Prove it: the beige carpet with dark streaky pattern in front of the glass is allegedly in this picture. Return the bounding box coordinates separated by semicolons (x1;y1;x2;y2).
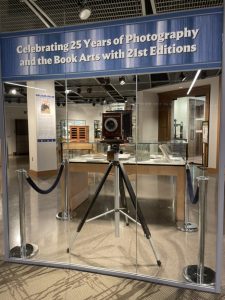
0;261;225;300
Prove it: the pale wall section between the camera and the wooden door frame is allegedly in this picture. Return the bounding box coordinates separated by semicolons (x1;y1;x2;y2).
137;91;159;143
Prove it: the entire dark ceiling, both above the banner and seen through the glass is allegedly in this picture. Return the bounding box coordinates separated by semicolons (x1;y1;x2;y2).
0;0;223;105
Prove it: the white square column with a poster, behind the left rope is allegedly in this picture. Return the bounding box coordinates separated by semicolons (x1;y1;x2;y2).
27;81;57;174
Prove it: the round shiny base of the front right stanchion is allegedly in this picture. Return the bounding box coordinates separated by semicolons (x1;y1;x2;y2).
183;265;215;285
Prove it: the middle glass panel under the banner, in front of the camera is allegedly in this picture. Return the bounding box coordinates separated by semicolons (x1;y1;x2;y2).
64;76;136;273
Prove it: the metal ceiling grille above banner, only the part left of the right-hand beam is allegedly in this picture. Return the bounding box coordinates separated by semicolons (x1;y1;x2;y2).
0;0;143;32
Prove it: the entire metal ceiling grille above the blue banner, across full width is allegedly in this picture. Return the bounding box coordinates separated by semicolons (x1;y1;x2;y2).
0;0;223;32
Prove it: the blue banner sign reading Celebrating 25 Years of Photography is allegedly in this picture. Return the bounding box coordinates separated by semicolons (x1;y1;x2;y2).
1;9;223;80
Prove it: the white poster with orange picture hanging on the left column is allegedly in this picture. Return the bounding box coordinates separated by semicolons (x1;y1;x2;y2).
35;94;56;142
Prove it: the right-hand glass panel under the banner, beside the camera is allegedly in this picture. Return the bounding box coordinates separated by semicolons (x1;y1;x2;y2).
137;70;219;284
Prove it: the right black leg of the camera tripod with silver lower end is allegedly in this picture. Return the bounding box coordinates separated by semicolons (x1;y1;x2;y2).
118;164;161;266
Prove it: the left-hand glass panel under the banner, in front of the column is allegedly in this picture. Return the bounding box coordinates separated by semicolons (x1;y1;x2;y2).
4;80;68;261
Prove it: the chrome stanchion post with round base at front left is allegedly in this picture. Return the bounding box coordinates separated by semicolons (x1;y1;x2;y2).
10;169;38;258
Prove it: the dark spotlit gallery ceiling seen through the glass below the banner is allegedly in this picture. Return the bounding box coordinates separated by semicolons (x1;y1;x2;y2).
4;70;220;106
